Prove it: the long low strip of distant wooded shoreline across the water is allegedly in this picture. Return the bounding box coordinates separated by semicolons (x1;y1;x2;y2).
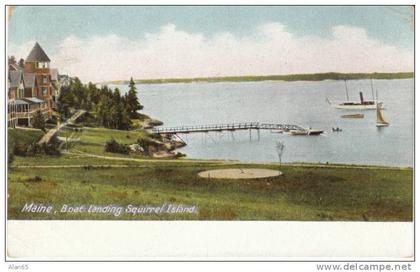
97;72;414;85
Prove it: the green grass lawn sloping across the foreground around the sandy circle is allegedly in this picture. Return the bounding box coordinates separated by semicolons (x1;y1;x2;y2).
8;126;413;221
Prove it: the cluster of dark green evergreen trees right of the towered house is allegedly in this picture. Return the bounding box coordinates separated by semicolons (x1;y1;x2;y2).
57;78;143;130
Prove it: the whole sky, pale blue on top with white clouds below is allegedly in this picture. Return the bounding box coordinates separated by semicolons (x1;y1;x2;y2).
8;6;414;82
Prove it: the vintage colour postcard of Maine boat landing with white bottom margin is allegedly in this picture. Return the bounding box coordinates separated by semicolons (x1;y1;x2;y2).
5;3;414;258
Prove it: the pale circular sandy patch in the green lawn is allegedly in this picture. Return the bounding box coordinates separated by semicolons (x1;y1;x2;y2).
198;168;282;179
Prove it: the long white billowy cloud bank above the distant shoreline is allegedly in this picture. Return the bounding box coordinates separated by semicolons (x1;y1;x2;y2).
7;22;414;82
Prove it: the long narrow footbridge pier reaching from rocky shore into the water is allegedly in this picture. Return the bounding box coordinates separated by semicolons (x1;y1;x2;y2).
152;122;304;134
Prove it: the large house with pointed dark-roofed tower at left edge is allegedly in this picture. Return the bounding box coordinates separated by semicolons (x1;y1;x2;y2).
8;43;59;127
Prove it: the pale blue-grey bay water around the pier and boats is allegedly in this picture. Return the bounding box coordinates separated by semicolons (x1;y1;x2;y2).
111;79;414;166
